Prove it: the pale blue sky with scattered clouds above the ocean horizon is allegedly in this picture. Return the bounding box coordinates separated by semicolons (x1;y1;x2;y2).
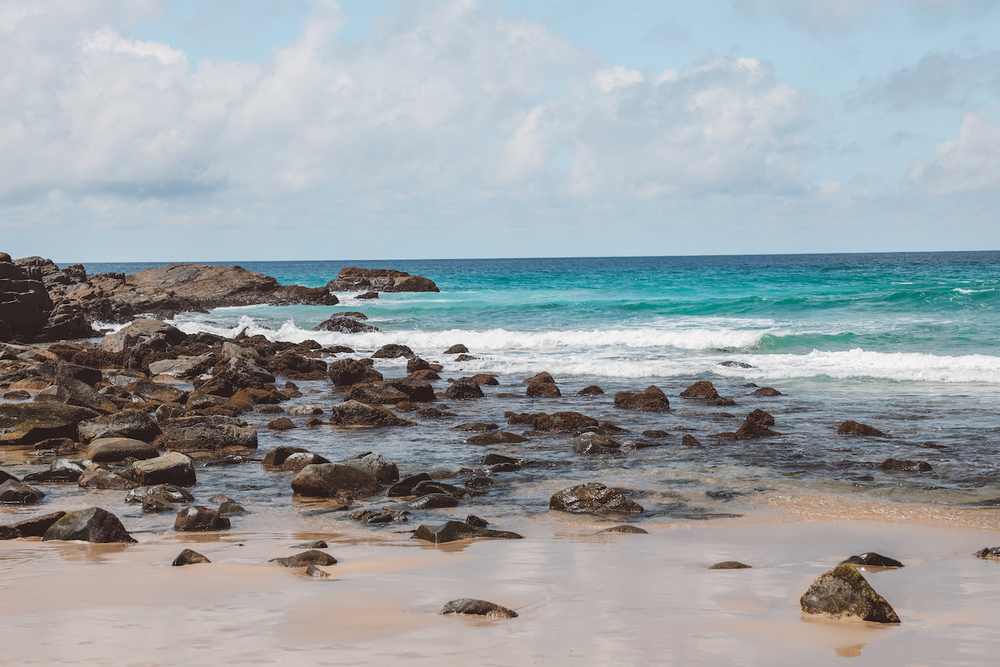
0;0;1000;262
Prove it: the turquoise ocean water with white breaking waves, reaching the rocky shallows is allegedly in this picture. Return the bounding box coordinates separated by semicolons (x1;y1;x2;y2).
70;252;1000;536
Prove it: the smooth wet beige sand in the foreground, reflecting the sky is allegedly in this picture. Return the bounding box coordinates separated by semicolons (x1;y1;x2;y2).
0;512;1000;665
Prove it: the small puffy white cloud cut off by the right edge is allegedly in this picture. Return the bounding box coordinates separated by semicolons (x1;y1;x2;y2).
907;110;1000;195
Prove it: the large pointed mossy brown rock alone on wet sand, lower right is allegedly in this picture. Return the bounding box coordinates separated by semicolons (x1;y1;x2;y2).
799;563;899;623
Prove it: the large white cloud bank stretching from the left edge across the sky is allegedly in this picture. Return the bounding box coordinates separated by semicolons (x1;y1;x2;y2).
0;0;810;210
